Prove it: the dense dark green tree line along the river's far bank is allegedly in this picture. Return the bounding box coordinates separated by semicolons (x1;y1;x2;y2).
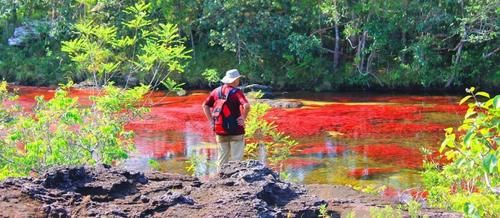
0;0;500;90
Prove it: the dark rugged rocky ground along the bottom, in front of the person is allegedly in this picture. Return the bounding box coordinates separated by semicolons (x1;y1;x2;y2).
0;161;457;217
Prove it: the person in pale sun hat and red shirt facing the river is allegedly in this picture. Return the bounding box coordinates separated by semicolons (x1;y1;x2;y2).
202;69;250;170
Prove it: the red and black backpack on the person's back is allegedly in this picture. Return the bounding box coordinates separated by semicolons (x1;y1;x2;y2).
212;86;238;134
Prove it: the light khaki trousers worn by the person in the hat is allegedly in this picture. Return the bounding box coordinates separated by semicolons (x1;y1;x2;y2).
215;135;245;171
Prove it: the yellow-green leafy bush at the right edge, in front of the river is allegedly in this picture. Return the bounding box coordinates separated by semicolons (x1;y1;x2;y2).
423;87;500;216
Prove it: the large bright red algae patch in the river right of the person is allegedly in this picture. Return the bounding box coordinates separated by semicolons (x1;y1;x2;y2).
266;104;456;137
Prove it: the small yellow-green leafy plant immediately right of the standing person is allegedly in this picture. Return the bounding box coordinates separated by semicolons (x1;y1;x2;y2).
245;100;298;175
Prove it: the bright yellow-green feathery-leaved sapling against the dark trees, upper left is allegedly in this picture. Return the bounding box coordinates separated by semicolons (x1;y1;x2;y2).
61;1;190;87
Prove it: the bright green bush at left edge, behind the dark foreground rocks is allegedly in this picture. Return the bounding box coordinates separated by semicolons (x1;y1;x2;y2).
0;82;149;179
